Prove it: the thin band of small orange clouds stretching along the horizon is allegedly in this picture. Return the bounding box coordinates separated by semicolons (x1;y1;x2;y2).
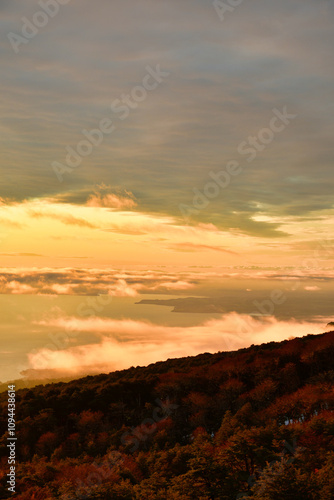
0;266;334;296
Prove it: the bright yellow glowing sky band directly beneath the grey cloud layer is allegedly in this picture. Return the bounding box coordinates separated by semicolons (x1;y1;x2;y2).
0;197;334;267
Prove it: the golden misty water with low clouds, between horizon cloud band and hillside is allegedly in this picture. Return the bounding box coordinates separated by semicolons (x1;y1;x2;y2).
0;279;333;382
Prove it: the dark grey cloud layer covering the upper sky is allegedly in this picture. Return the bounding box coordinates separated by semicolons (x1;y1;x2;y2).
0;0;334;234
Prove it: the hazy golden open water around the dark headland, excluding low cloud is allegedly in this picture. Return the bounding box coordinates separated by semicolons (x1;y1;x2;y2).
0;279;328;382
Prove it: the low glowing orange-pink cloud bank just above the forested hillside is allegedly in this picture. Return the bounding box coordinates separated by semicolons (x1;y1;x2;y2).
25;313;323;377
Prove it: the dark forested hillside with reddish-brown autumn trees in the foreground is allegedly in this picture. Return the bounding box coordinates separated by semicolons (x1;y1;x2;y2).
0;332;334;500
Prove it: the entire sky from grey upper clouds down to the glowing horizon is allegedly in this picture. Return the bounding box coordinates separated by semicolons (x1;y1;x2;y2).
0;0;334;384
